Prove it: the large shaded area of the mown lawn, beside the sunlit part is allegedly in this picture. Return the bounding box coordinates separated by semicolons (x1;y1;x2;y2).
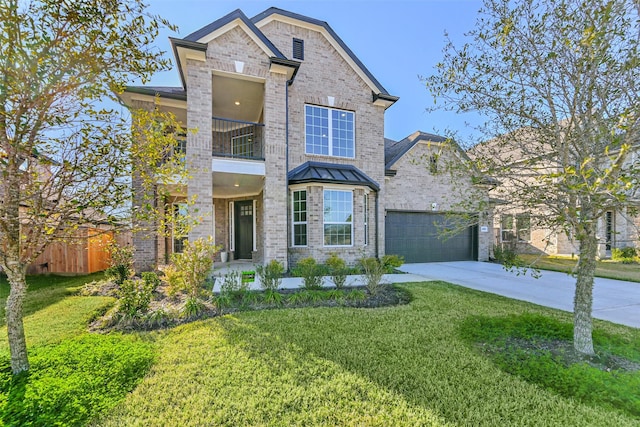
211;283;637;425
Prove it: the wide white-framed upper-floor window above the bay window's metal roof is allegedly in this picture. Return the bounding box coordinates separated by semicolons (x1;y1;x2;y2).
305;105;355;158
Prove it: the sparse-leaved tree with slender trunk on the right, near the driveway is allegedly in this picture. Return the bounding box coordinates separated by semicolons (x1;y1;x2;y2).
424;0;640;354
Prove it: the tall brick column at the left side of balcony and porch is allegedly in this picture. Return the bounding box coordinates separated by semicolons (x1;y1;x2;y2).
186;59;214;241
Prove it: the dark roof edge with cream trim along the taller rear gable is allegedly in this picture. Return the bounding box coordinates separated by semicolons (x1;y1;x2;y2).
251;7;398;105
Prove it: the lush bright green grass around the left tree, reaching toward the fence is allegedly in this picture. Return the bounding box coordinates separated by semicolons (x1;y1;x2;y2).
0;275;155;426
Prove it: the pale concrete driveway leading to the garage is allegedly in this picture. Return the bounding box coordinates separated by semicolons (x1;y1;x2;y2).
400;261;640;328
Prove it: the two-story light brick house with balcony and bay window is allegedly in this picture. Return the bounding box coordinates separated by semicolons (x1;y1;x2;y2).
121;8;487;269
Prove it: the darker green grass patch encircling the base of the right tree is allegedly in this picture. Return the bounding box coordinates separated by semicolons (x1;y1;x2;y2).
461;314;640;417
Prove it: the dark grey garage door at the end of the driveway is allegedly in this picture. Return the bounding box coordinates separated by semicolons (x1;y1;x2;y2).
385;211;478;262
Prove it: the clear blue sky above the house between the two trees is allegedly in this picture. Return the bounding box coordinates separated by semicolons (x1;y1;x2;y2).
140;0;481;144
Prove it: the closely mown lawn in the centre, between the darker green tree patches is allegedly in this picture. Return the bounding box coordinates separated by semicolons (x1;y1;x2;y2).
98;282;640;426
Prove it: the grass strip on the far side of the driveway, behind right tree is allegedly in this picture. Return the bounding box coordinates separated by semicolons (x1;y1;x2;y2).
519;255;640;282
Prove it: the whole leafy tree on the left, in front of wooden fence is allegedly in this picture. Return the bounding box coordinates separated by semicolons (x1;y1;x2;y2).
0;0;182;373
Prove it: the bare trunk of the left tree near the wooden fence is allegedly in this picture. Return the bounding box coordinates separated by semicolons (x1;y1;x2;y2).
6;265;29;375
